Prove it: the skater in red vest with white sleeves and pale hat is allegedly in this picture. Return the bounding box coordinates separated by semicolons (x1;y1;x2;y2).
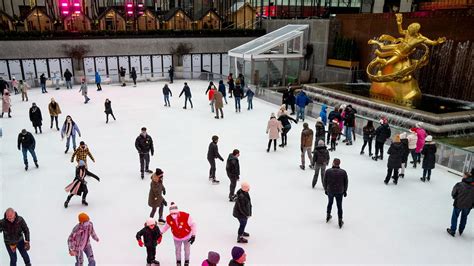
161;202;196;266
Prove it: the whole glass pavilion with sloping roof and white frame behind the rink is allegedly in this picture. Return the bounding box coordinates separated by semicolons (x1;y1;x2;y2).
228;25;309;88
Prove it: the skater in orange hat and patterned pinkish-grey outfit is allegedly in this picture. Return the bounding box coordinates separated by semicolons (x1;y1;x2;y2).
67;212;99;266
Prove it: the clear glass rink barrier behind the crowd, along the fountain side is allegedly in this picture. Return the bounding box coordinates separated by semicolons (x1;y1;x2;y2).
254;87;474;175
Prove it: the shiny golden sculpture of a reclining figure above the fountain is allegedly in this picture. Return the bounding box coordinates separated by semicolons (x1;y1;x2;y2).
367;14;446;106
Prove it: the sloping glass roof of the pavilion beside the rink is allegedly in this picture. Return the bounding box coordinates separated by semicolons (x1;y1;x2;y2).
229;25;309;57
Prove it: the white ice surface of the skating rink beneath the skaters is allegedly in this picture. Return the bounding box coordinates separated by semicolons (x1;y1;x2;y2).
0;80;474;266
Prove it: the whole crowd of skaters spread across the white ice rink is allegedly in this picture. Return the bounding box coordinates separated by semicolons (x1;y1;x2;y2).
0;68;474;266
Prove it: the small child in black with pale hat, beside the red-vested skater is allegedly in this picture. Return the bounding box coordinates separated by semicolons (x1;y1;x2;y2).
135;218;162;266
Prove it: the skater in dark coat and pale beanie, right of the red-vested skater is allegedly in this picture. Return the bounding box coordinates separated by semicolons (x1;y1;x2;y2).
233;182;252;243
